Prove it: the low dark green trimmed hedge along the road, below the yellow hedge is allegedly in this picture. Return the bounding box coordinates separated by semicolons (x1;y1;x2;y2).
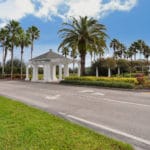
61;80;134;89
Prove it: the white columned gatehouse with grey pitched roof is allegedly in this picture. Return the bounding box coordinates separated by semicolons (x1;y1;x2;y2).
25;50;81;82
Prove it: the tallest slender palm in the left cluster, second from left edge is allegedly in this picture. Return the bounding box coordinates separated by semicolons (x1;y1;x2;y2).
6;20;21;79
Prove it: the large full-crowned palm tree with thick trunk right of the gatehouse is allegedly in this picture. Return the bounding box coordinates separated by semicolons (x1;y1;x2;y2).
58;16;107;75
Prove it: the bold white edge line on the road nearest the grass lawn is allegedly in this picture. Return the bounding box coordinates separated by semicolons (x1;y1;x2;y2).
63;113;150;145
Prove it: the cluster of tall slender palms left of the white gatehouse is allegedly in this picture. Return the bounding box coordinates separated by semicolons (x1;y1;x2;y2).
0;20;40;79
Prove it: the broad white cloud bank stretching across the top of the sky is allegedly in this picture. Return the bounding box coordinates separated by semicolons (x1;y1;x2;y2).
0;0;138;26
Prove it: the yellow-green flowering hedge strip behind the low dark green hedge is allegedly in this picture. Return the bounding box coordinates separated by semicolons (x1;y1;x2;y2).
65;76;138;84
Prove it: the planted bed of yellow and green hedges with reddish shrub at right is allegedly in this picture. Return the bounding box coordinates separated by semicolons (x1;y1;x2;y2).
61;76;149;89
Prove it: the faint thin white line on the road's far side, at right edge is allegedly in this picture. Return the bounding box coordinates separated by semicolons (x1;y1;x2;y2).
103;98;150;107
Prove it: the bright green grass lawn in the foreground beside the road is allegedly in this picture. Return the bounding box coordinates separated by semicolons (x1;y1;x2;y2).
0;96;133;150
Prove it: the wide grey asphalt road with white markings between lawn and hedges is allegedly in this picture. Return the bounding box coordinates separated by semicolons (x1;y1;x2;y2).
0;80;150;150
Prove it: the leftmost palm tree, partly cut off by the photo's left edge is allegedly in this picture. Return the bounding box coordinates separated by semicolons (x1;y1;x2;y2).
0;28;8;75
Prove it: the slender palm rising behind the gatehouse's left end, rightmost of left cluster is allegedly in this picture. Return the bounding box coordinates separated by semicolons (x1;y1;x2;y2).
27;26;40;59
